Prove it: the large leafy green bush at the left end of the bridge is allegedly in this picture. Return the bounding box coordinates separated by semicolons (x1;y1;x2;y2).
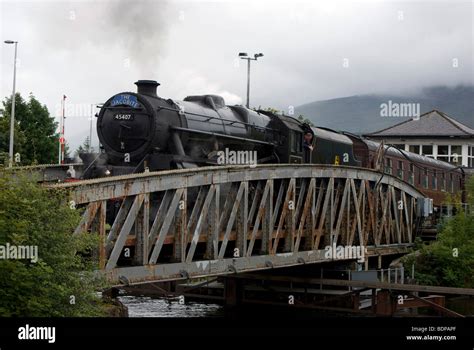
0;174;105;317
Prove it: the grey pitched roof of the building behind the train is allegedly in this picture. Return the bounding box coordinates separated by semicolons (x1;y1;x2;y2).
364;109;474;137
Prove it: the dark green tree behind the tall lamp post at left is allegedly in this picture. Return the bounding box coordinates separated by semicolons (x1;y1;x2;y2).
0;93;59;165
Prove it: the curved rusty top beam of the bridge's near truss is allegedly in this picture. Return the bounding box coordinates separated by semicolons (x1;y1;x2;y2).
48;164;423;204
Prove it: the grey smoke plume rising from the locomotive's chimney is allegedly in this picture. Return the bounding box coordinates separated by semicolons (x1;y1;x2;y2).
25;0;170;77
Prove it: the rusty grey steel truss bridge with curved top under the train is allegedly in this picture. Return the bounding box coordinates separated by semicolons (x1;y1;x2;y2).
51;165;423;285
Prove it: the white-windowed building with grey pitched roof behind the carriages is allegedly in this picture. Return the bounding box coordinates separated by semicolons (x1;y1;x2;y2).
364;110;474;168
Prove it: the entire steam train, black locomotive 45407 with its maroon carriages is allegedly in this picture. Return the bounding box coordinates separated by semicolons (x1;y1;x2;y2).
84;80;464;215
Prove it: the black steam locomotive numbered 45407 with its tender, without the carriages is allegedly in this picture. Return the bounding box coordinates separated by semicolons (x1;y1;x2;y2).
85;80;361;178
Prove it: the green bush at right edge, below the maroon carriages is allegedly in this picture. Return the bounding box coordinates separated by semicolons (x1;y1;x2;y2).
404;177;474;288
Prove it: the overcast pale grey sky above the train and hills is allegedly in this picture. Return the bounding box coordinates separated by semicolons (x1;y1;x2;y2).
0;0;474;149
